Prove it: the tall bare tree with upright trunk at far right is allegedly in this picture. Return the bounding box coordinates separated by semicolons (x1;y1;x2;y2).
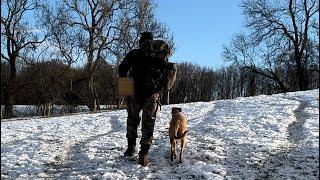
241;0;319;90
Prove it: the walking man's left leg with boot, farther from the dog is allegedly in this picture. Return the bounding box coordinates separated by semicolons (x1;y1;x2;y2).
124;97;142;156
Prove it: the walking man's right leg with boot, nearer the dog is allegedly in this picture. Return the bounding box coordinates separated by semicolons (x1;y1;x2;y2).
139;94;159;166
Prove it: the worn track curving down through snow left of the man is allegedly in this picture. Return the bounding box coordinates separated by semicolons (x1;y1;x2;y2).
44;113;125;179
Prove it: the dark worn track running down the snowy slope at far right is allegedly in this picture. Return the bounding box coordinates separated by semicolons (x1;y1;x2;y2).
257;97;317;179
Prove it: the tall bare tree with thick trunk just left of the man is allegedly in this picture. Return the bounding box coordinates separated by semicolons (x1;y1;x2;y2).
40;0;129;112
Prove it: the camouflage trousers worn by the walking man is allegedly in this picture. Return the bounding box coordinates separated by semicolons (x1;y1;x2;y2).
126;93;160;146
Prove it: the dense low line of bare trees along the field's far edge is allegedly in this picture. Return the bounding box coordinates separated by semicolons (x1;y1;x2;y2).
1;60;319;115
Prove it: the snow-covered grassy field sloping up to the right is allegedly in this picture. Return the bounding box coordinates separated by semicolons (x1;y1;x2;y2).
1;89;319;180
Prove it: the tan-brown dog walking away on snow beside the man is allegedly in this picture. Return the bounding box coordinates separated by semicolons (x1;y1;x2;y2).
169;107;188;163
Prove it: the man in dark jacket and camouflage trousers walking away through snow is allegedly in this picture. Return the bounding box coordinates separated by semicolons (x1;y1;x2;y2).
119;32;170;166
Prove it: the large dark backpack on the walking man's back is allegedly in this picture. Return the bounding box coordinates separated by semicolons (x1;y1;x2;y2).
142;40;177;100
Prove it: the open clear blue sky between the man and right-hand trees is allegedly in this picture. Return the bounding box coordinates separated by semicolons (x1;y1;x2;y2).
156;0;244;68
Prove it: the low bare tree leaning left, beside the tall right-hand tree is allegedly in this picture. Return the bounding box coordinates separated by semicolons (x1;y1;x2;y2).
223;34;288;95
